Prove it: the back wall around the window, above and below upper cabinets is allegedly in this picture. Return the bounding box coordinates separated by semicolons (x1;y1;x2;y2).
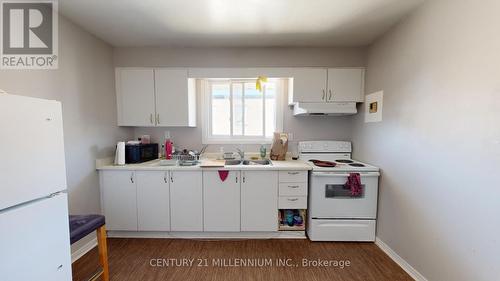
114;47;366;152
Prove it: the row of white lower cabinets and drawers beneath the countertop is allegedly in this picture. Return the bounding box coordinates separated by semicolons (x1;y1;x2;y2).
100;167;298;232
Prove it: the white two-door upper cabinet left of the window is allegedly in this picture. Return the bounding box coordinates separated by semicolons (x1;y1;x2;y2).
116;67;196;127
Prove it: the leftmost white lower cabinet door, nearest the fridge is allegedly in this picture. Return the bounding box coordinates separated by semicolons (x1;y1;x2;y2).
101;171;137;231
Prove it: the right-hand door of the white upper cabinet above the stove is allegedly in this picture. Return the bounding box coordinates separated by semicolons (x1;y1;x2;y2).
327;68;365;102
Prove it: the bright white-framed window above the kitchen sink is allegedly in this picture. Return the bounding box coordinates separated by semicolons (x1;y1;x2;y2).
202;79;284;144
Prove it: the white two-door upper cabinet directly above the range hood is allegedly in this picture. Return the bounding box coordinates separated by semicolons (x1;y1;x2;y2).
288;68;364;104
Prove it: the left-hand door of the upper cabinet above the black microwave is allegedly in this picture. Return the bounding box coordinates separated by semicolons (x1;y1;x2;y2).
115;68;155;127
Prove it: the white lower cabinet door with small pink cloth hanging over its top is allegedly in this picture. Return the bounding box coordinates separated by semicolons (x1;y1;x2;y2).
203;171;241;231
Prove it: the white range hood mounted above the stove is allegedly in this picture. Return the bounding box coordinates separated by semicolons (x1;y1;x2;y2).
293;102;358;116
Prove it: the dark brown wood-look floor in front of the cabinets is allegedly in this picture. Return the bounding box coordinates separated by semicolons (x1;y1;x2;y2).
73;238;413;281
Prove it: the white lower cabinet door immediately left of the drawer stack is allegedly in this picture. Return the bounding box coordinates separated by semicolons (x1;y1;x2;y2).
241;171;278;231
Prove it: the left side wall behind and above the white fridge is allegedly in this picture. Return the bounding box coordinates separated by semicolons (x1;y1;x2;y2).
0;16;132;253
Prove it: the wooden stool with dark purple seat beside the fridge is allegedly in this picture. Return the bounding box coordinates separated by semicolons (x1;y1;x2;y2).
69;215;109;281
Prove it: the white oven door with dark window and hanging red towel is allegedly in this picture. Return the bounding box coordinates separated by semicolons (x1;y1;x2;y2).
309;172;380;219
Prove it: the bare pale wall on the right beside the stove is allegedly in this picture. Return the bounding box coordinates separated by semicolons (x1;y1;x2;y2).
353;0;500;281
